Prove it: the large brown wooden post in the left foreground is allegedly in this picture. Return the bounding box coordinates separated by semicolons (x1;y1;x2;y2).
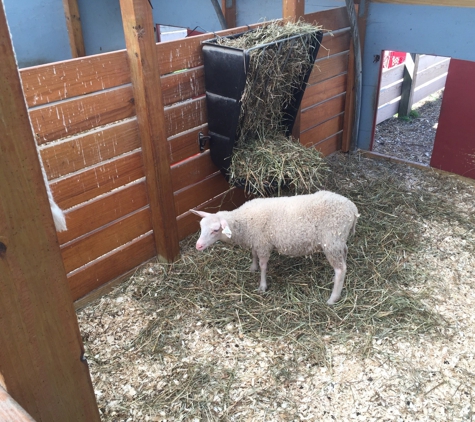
0;1;99;422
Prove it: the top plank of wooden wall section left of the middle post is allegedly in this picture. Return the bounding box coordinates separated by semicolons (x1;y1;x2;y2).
20;50;130;107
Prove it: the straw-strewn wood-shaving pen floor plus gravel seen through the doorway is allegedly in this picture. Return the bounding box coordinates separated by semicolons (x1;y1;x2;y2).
78;93;475;421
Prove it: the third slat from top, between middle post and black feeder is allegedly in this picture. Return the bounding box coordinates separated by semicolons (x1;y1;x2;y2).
165;97;207;137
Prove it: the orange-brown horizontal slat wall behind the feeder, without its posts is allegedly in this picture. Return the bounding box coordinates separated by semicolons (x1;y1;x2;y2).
21;8;352;300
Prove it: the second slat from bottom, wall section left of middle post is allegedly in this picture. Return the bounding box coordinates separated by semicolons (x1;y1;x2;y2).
61;207;152;273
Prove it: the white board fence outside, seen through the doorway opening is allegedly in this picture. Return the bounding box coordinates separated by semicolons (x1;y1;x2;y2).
376;54;450;124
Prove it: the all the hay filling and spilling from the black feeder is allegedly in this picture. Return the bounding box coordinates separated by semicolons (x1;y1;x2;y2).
217;22;324;196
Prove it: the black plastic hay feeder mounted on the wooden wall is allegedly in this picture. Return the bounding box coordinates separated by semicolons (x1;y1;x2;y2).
200;31;323;176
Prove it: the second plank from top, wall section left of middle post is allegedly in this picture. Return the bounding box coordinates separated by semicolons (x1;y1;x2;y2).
30;86;135;145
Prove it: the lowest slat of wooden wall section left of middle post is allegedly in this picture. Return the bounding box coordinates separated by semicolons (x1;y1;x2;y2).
68;233;156;300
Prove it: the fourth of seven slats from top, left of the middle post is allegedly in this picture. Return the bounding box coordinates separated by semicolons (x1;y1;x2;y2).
50;151;144;209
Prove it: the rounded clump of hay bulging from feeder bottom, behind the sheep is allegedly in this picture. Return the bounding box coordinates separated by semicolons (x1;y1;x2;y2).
229;134;329;196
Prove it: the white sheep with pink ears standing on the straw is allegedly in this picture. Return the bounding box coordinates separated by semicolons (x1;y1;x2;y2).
192;191;359;305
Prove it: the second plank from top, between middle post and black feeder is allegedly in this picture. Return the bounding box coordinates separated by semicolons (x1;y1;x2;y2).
161;66;205;106
